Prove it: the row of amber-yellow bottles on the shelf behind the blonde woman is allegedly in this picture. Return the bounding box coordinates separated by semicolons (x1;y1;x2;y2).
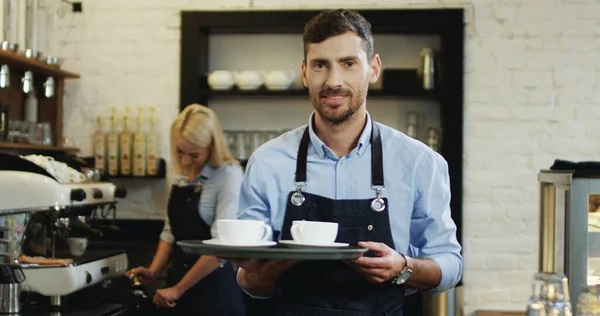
94;107;158;177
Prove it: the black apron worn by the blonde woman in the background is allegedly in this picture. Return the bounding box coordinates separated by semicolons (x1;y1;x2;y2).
165;183;245;316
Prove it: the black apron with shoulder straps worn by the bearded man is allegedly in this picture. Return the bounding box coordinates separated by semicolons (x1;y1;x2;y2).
253;124;404;316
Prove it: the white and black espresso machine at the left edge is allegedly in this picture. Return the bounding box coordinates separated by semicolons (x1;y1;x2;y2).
0;153;128;315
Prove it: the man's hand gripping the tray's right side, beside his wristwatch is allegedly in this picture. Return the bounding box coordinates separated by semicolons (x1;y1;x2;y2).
349;241;406;283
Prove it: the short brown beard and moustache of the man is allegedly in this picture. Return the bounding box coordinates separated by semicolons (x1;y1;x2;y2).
310;87;367;126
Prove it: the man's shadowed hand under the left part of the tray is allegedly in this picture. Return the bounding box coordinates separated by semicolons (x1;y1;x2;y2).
222;258;300;295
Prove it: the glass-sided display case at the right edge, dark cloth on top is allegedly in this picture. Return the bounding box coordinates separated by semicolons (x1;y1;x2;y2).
538;162;600;315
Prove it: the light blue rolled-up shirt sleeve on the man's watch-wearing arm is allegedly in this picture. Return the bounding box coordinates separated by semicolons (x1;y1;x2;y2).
410;154;463;294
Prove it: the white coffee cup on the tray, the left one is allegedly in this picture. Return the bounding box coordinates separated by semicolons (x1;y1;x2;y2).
217;219;273;245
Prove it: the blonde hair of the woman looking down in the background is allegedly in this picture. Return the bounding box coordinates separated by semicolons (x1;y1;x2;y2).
171;104;239;174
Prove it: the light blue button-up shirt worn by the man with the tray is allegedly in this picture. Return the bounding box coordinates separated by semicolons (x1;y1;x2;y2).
238;113;463;293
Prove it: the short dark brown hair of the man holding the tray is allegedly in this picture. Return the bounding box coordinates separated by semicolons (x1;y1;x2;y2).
302;9;373;59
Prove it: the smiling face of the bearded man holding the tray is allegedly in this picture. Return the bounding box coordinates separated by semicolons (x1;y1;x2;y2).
302;32;381;125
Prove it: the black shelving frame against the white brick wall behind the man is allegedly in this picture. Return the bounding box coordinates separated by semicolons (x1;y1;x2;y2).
180;8;464;315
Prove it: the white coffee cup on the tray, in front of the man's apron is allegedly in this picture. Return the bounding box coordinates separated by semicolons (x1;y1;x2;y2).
290;221;338;245
